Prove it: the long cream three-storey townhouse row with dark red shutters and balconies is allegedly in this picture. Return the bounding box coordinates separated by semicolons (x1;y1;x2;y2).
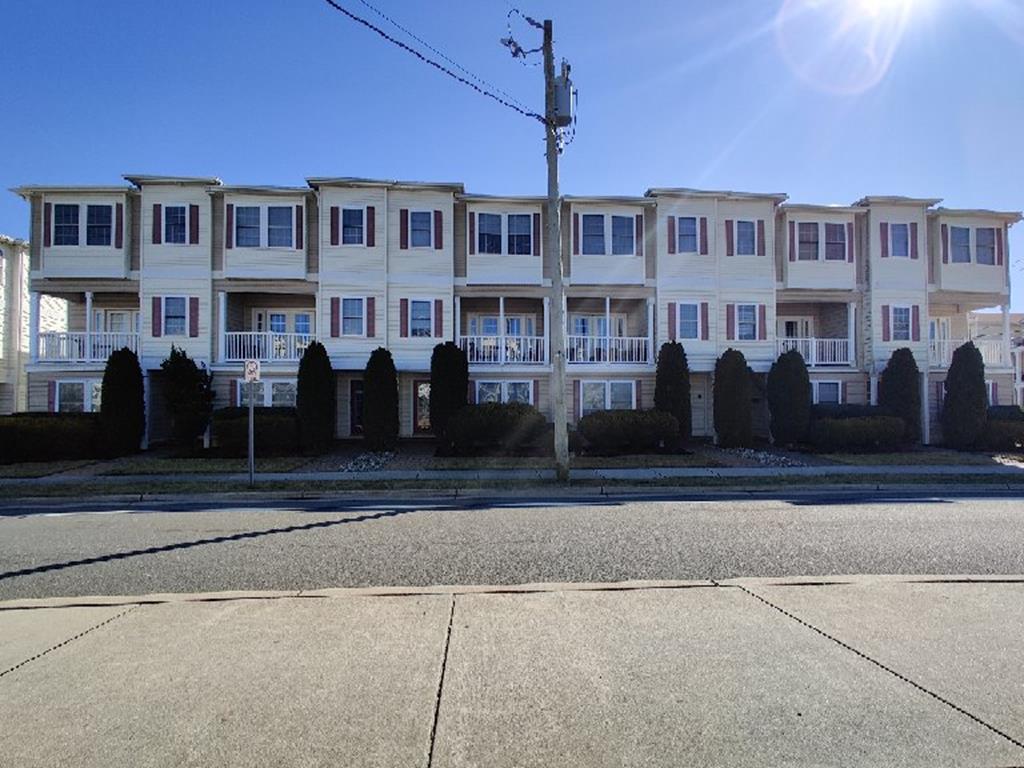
9;175;1021;441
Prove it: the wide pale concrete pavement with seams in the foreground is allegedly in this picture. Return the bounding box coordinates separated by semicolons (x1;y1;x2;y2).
0;578;1024;768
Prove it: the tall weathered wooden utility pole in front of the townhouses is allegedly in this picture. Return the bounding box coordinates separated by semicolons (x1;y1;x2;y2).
543;18;569;482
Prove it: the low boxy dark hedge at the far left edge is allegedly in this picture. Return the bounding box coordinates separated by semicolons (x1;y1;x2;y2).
0;414;103;464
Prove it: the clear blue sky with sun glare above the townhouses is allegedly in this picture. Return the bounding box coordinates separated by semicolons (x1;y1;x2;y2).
0;0;1024;310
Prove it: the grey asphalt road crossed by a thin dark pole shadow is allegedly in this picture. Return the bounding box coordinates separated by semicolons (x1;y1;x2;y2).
0;495;1024;599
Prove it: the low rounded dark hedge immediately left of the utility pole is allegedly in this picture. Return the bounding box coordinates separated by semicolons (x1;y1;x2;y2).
447;402;548;456
